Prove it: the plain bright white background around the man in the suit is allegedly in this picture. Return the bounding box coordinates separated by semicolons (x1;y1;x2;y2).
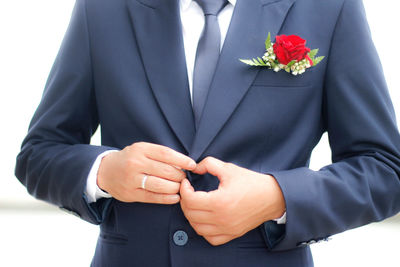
0;0;400;267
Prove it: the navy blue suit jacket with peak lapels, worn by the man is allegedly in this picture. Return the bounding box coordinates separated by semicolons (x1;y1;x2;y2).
16;0;400;267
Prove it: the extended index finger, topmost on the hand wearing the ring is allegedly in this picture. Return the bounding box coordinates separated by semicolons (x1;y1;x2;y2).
144;143;197;170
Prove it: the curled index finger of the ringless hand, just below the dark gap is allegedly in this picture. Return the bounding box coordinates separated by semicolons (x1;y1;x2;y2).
180;179;211;211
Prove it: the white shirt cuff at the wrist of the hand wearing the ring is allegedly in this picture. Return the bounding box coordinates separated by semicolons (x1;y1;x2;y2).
85;150;118;203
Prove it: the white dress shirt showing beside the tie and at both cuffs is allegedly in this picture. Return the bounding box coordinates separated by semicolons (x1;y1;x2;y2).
85;0;286;223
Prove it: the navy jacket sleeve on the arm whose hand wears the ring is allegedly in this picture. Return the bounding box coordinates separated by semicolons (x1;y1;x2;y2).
15;0;115;224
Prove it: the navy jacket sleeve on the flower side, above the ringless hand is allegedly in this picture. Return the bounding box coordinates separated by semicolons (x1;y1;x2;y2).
264;0;400;250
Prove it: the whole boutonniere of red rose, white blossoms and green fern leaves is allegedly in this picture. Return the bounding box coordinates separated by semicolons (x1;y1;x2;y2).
240;33;324;75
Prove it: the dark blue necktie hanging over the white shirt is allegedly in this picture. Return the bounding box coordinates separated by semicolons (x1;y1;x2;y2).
193;0;228;128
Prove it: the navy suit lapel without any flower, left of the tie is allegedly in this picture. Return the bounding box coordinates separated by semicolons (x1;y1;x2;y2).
127;0;195;151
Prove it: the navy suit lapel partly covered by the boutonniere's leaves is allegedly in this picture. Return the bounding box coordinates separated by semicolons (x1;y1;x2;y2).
190;0;295;160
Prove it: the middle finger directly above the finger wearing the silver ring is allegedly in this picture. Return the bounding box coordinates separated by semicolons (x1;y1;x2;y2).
143;159;186;182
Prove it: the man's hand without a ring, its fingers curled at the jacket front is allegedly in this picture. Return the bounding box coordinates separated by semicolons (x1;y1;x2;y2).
180;157;285;246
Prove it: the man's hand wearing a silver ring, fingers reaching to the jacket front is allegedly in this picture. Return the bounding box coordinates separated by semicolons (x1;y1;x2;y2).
97;142;196;204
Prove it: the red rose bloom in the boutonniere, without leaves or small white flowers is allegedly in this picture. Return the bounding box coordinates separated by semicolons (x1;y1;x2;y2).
274;34;312;65
